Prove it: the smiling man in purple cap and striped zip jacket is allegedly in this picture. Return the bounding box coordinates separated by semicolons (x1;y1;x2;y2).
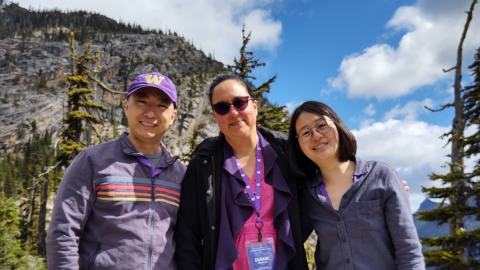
47;72;185;270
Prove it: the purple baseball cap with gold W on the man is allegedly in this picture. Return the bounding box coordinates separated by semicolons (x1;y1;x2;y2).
126;72;177;109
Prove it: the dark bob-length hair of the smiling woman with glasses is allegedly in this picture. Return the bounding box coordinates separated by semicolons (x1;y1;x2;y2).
287;101;357;177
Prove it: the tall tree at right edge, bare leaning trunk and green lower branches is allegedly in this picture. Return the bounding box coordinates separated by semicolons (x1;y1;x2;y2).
418;0;480;270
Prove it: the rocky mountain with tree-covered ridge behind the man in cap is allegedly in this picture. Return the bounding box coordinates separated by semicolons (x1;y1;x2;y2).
0;3;229;155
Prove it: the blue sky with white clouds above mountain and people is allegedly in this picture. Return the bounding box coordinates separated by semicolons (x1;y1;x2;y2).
18;0;480;211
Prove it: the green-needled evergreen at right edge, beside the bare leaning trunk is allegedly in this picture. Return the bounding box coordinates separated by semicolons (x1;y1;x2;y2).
419;48;480;269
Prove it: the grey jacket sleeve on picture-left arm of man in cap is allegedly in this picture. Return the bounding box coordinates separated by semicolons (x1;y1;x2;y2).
47;151;95;270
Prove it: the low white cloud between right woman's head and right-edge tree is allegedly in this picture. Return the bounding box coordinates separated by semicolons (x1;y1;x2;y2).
352;119;450;210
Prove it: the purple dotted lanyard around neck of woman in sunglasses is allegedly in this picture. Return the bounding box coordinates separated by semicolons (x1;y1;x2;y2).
235;133;263;242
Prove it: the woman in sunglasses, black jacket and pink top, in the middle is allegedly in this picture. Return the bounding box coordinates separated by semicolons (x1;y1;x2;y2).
175;75;308;270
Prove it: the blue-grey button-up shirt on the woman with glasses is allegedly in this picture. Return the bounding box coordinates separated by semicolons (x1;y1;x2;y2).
299;157;425;270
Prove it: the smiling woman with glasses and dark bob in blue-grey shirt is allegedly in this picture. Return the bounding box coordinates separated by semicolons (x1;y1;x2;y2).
287;101;425;270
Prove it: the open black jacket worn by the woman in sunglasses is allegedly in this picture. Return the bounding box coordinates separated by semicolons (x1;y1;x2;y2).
174;127;308;270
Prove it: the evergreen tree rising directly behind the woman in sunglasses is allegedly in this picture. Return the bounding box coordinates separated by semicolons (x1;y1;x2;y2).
229;25;290;132
